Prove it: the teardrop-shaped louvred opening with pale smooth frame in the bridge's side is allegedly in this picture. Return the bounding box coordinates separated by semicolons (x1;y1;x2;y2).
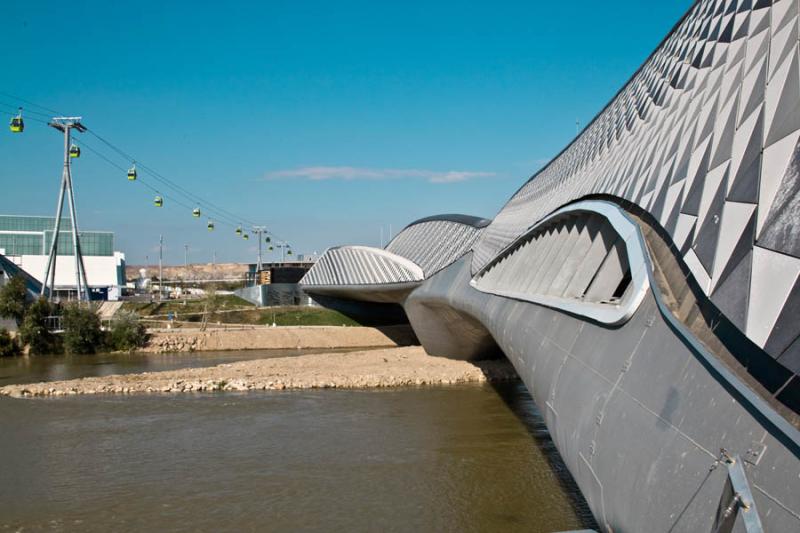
470;200;649;325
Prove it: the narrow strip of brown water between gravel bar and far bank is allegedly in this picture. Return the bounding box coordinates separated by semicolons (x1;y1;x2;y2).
0;348;352;387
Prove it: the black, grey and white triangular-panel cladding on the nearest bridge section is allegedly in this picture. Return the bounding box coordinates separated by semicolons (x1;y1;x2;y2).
472;0;800;358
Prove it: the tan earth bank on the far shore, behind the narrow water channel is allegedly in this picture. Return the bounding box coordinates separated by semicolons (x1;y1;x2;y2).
142;326;417;353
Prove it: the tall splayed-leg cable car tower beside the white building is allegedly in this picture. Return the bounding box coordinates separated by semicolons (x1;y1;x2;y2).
42;117;89;301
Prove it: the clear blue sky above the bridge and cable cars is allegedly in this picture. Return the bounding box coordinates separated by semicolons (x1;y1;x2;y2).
0;0;692;264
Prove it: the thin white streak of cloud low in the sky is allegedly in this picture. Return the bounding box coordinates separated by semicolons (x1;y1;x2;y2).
266;166;495;183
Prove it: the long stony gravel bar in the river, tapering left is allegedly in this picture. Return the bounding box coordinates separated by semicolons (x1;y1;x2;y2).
0;346;517;397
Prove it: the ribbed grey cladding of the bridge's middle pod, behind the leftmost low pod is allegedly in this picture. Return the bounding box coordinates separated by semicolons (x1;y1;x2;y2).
386;219;482;278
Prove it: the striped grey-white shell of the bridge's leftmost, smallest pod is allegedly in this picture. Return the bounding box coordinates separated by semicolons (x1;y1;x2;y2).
300;246;423;286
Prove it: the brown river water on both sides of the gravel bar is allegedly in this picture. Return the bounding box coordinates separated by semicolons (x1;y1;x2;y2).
0;350;594;532
